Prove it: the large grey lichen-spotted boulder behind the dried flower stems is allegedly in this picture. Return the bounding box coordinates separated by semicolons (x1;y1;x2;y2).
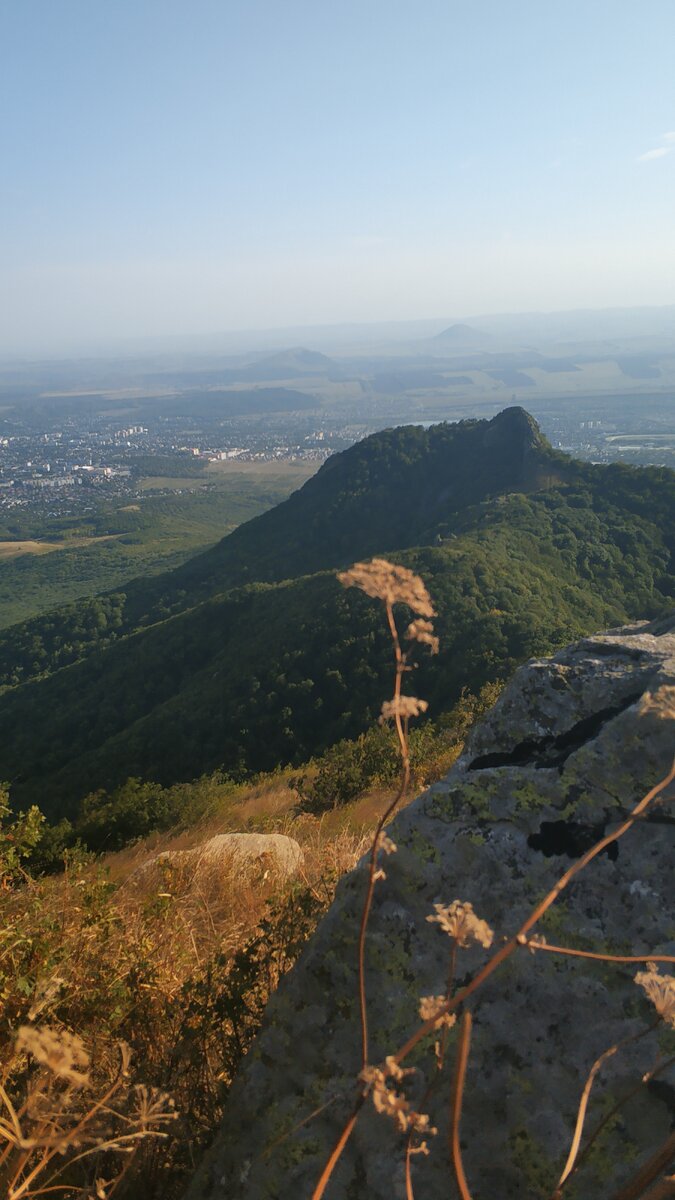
189;616;675;1200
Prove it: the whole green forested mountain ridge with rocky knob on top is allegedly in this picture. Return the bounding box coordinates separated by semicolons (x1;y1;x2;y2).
0;409;675;816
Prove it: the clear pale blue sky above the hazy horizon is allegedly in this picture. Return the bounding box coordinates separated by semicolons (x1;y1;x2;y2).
0;0;675;355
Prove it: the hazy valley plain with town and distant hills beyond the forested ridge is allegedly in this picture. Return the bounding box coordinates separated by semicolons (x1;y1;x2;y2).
0;308;675;625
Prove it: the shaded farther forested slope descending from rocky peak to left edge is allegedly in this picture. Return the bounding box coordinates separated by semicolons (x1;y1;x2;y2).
0;408;557;684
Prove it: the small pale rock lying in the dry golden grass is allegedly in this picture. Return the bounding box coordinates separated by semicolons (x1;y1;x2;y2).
130;833;304;878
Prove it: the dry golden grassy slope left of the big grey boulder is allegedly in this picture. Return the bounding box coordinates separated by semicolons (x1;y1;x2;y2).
0;779;369;1200
